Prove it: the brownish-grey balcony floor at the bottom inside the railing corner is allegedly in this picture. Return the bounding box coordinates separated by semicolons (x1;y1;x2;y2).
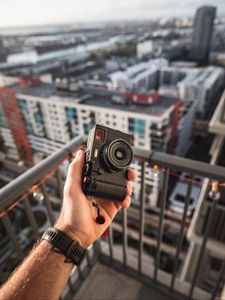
73;263;171;300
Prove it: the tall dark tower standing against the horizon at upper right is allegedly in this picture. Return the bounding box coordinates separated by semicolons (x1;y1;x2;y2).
191;6;216;64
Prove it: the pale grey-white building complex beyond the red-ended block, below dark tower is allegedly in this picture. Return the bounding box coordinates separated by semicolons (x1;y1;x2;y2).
109;59;225;117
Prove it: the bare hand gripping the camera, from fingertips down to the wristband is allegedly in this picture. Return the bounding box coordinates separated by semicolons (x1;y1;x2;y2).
55;150;137;248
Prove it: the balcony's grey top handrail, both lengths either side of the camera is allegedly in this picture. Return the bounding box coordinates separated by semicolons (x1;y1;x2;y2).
0;141;225;211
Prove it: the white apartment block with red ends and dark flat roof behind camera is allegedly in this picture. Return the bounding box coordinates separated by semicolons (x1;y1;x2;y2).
0;76;183;206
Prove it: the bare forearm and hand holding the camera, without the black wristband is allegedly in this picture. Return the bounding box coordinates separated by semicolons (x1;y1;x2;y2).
0;150;136;300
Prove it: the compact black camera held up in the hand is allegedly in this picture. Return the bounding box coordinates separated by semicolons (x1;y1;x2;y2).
82;124;133;201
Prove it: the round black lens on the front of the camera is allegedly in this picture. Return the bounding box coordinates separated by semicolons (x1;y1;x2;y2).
103;139;133;172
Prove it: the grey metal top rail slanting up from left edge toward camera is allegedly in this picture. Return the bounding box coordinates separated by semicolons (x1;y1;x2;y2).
0;136;86;211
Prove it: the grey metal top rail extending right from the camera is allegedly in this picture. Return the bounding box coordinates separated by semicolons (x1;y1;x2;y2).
134;148;225;181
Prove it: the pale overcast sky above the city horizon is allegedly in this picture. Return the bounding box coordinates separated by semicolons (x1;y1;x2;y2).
0;0;225;27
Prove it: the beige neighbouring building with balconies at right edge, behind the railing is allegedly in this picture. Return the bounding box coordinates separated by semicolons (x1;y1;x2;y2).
181;93;225;290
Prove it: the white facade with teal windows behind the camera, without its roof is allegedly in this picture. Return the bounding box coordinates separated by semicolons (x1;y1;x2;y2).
2;83;178;206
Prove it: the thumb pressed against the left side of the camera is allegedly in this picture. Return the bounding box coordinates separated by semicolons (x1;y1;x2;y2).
69;150;84;189
